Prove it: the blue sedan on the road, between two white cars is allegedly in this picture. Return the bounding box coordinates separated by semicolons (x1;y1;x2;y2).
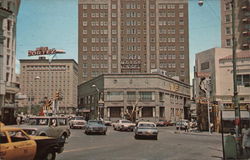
85;120;107;135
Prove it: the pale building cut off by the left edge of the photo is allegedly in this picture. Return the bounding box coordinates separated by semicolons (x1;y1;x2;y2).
0;0;20;124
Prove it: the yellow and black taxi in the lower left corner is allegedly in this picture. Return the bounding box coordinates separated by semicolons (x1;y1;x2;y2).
0;125;64;160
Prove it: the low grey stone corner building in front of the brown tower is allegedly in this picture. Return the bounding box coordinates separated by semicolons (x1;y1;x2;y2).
78;74;190;121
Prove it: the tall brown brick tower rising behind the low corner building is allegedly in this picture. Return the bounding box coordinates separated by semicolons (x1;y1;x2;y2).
78;0;189;84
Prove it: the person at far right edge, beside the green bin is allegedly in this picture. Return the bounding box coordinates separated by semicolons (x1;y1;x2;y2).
241;124;250;157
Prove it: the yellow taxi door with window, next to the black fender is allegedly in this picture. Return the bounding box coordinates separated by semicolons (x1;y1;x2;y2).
7;130;36;160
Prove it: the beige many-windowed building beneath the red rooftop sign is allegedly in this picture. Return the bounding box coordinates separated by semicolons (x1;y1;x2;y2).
20;57;78;113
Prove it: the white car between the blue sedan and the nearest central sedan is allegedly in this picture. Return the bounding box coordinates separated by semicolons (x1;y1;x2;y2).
112;120;135;131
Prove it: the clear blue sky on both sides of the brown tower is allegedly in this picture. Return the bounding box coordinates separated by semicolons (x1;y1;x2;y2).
16;0;221;83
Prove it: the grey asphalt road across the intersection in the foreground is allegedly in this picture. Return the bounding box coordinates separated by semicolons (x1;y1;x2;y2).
57;127;222;160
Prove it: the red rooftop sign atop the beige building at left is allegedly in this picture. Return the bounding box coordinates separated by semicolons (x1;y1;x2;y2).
28;47;65;56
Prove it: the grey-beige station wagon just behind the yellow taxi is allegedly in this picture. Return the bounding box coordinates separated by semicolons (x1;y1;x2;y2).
19;116;70;140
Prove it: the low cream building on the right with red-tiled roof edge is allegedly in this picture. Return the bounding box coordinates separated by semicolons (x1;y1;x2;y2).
194;48;250;131
